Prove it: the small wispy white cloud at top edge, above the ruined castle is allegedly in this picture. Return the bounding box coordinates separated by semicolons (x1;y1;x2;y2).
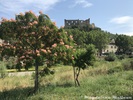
71;0;93;8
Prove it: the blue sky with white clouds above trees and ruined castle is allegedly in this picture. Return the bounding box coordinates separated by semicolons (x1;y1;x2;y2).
0;0;133;36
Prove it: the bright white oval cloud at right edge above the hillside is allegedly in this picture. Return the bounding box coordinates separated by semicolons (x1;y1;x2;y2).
110;16;133;24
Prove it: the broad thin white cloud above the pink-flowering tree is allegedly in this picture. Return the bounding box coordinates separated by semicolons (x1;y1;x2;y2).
0;0;61;17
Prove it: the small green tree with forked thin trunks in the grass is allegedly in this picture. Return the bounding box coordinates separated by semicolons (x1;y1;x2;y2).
73;45;95;86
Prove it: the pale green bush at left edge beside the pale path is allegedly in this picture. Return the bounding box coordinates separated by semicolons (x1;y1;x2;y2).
0;62;7;78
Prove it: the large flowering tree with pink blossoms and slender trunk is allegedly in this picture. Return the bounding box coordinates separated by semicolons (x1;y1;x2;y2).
0;11;73;92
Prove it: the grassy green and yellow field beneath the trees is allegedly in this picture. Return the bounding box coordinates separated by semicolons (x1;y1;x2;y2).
0;59;133;100
